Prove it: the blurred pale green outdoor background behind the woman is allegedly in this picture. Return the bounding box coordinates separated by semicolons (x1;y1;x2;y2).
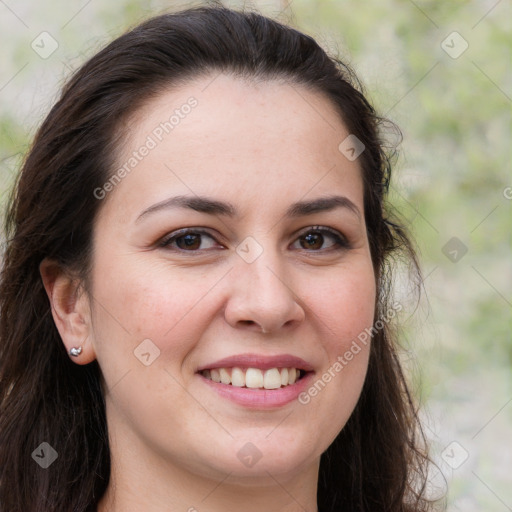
0;0;512;512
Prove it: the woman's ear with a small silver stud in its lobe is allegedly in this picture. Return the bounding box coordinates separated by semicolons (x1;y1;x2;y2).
39;258;96;364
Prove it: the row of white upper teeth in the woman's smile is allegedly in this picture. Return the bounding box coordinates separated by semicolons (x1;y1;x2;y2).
201;367;300;389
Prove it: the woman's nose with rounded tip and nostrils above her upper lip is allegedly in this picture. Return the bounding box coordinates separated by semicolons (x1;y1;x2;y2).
224;246;305;333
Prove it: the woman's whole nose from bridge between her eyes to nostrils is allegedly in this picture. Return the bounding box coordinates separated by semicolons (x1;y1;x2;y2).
226;240;304;332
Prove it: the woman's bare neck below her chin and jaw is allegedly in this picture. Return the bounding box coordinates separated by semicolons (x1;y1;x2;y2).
97;416;320;512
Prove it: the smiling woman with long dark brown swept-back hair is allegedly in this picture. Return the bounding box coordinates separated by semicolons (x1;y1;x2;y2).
0;7;440;512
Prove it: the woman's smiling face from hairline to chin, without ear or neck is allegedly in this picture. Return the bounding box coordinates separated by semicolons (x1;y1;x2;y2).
87;75;376;482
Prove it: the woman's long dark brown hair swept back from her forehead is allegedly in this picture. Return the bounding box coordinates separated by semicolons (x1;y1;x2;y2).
0;7;440;512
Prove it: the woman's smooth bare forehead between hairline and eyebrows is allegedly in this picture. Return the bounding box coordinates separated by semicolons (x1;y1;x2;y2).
103;74;362;222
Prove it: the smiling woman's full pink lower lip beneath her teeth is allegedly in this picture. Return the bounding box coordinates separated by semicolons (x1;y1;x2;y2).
198;372;314;409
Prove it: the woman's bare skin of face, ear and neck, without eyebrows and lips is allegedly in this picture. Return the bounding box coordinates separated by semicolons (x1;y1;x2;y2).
41;74;376;512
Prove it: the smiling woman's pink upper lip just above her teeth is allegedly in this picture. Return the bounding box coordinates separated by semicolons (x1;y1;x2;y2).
196;354;314;372
